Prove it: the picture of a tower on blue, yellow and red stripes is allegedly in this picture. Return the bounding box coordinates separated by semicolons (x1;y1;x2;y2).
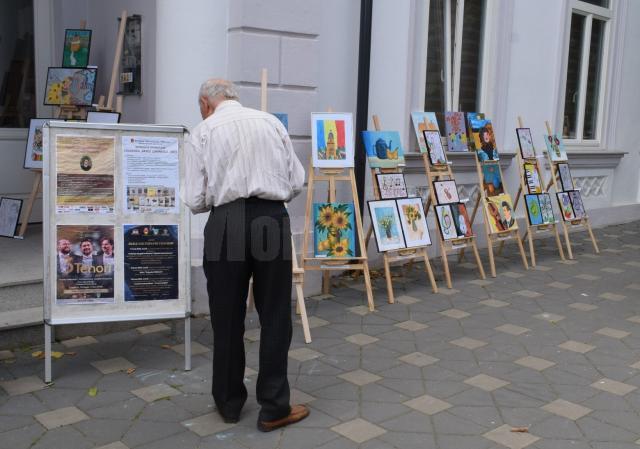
311;112;353;168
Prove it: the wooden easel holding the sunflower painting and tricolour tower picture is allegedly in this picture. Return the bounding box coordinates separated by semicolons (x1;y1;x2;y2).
302;117;375;311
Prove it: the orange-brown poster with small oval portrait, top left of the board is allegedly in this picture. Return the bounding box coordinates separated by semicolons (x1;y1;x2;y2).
56;135;115;214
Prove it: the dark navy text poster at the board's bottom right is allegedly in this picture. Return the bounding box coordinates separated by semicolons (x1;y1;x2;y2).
124;225;179;301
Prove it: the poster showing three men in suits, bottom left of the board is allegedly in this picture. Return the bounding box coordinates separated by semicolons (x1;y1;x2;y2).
56;225;116;305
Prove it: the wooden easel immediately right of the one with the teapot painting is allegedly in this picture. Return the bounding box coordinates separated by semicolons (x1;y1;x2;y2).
422;123;487;288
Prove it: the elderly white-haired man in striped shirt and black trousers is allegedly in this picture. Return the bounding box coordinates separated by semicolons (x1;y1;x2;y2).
182;79;309;432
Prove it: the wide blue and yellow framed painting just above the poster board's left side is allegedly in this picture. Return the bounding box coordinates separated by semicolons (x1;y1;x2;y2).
44;67;98;106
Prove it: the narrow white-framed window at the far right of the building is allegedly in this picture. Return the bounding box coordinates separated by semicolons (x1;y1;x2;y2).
562;0;613;144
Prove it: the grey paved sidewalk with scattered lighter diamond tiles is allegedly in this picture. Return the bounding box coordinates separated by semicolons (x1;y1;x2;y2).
0;222;640;449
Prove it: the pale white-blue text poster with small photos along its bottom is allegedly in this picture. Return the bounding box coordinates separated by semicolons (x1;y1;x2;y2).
122;136;180;214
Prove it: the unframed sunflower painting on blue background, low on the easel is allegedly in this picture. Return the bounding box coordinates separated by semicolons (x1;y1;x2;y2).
313;203;356;258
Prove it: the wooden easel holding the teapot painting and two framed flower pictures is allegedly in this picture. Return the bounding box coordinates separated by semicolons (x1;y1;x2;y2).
365;115;438;304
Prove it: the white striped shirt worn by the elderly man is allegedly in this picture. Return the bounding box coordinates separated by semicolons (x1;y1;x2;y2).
181;100;304;214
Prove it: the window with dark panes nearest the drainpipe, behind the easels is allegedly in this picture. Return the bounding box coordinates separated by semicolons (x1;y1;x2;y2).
424;0;486;129
